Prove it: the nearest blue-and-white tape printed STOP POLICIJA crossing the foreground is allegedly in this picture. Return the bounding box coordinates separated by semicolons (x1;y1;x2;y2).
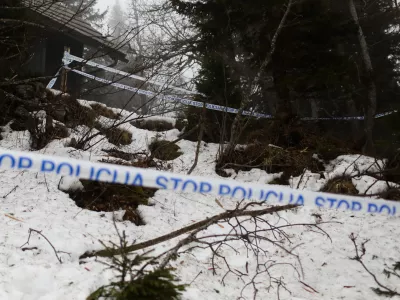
0;148;400;216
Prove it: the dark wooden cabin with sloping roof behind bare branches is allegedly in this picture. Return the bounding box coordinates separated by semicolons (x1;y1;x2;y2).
15;0;127;96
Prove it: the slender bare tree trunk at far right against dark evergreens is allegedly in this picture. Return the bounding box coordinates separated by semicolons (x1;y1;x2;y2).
349;0;376;154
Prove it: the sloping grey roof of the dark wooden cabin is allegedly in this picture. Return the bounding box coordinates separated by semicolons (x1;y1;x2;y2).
22;0;127;62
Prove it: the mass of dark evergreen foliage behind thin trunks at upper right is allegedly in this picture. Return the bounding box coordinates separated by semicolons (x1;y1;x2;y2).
170;0;400;148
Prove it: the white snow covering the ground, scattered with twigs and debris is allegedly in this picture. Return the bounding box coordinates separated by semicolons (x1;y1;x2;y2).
0;101;400;300
